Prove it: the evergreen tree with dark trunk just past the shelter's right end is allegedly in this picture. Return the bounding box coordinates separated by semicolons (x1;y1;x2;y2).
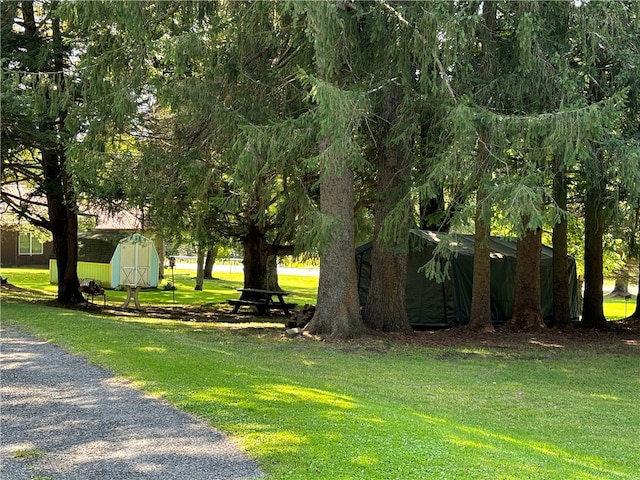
573;1;640;327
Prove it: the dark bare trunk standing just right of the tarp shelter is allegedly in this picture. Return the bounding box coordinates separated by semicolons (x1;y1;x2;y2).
581;174;607;328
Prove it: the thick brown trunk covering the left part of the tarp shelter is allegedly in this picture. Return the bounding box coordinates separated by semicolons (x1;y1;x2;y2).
363;82;413;334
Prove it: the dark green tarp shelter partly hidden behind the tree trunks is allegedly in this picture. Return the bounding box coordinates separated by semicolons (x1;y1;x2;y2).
356;230;580;327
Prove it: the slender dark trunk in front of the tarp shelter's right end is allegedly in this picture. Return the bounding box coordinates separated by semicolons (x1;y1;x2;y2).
552;163;571;328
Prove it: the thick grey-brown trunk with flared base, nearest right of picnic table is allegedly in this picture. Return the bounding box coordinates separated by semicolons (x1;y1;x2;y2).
307;140;364;338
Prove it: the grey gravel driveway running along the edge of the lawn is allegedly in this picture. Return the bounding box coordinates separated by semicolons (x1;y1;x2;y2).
0;324;263;480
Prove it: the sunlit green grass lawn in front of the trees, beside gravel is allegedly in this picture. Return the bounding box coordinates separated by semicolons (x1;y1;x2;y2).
1;269;640;480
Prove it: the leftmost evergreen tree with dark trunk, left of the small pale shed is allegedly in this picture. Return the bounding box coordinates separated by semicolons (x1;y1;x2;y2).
1;1;82;303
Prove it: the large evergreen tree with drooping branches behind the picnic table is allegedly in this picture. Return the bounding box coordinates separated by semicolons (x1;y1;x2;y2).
65;2;310;289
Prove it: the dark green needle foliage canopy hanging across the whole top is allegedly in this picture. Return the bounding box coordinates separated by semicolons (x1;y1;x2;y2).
2;0;640;328
